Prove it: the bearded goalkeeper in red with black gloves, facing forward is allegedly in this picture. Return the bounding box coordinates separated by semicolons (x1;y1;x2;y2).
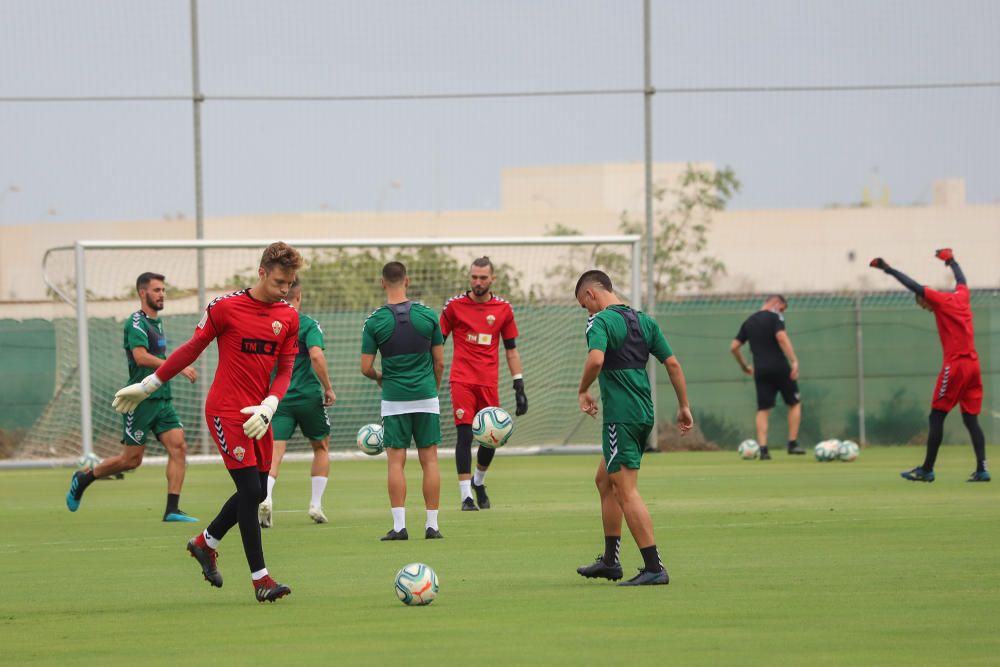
441;257;528;512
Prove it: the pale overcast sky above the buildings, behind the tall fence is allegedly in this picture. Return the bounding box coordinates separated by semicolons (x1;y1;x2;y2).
0;0;1000;224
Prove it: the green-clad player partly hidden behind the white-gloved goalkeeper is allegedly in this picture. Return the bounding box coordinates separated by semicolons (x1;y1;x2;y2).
257;281;337;528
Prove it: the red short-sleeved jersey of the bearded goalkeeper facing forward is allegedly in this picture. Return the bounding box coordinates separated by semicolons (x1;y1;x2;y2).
441;292;517;387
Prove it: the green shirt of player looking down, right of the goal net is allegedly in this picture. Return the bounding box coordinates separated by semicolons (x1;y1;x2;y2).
587;305;673;424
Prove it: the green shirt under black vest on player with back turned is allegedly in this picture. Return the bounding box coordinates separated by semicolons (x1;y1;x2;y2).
361;302;444;402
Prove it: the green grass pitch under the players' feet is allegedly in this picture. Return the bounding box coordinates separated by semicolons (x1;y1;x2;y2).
0;446;1000;667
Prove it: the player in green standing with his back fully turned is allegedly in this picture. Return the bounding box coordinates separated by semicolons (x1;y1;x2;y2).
361;262;444;541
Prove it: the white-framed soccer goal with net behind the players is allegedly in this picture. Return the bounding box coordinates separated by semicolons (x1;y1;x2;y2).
16;236;641;463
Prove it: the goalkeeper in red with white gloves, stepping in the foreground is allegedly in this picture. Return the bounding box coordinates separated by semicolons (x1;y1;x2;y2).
112;242;302;602
